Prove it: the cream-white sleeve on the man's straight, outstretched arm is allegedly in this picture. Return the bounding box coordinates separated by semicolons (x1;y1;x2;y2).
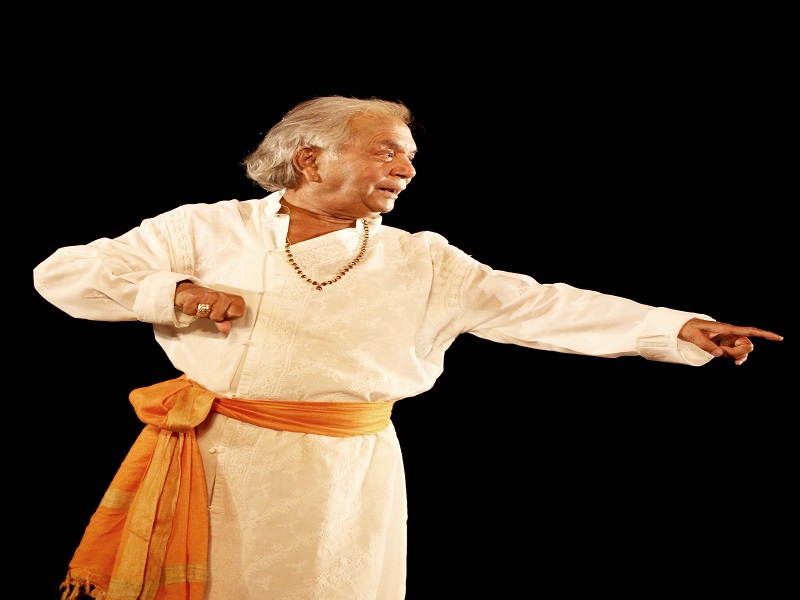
450;251;713;366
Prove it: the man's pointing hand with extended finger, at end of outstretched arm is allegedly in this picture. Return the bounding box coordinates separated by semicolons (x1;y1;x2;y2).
678;318;783;365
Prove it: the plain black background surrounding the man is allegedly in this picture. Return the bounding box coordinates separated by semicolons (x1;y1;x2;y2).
20;21;797;600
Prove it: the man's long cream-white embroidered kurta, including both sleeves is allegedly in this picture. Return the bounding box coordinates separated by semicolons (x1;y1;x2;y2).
34;193;711;600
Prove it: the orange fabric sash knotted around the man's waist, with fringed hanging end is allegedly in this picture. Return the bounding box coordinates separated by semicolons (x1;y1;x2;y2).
61;375;393;600
